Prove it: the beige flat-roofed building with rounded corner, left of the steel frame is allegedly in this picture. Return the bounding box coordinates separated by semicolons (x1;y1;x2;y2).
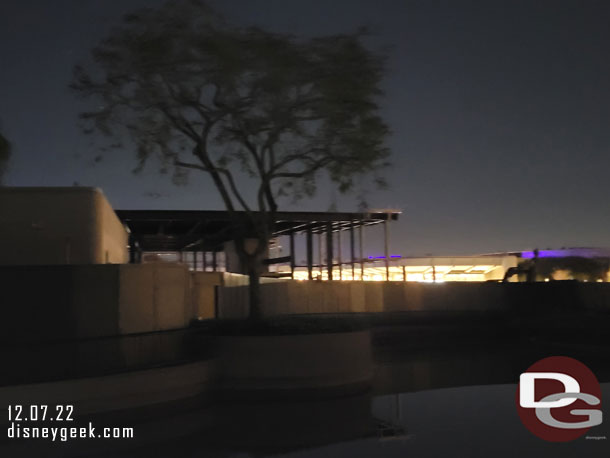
0;187;128;265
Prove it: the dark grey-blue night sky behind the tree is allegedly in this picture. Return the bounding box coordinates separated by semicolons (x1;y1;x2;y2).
0;0;610;255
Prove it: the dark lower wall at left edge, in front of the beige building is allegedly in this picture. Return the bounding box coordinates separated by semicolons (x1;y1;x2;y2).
0;263;194;342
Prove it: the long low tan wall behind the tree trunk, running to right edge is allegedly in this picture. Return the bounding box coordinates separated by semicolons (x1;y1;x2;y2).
218;282;610;318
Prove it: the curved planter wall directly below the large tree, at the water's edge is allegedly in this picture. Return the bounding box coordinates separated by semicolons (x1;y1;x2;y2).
218;330;373;392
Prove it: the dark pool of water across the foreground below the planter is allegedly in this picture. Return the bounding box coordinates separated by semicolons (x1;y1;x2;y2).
0;342;610;458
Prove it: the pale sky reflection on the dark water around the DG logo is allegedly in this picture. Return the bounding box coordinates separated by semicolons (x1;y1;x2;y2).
284;383;610;458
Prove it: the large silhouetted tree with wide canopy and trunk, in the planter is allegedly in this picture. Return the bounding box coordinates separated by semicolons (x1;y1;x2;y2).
72;1;389;316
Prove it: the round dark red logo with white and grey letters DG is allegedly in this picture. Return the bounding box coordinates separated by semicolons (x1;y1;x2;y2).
517;356;602;442
